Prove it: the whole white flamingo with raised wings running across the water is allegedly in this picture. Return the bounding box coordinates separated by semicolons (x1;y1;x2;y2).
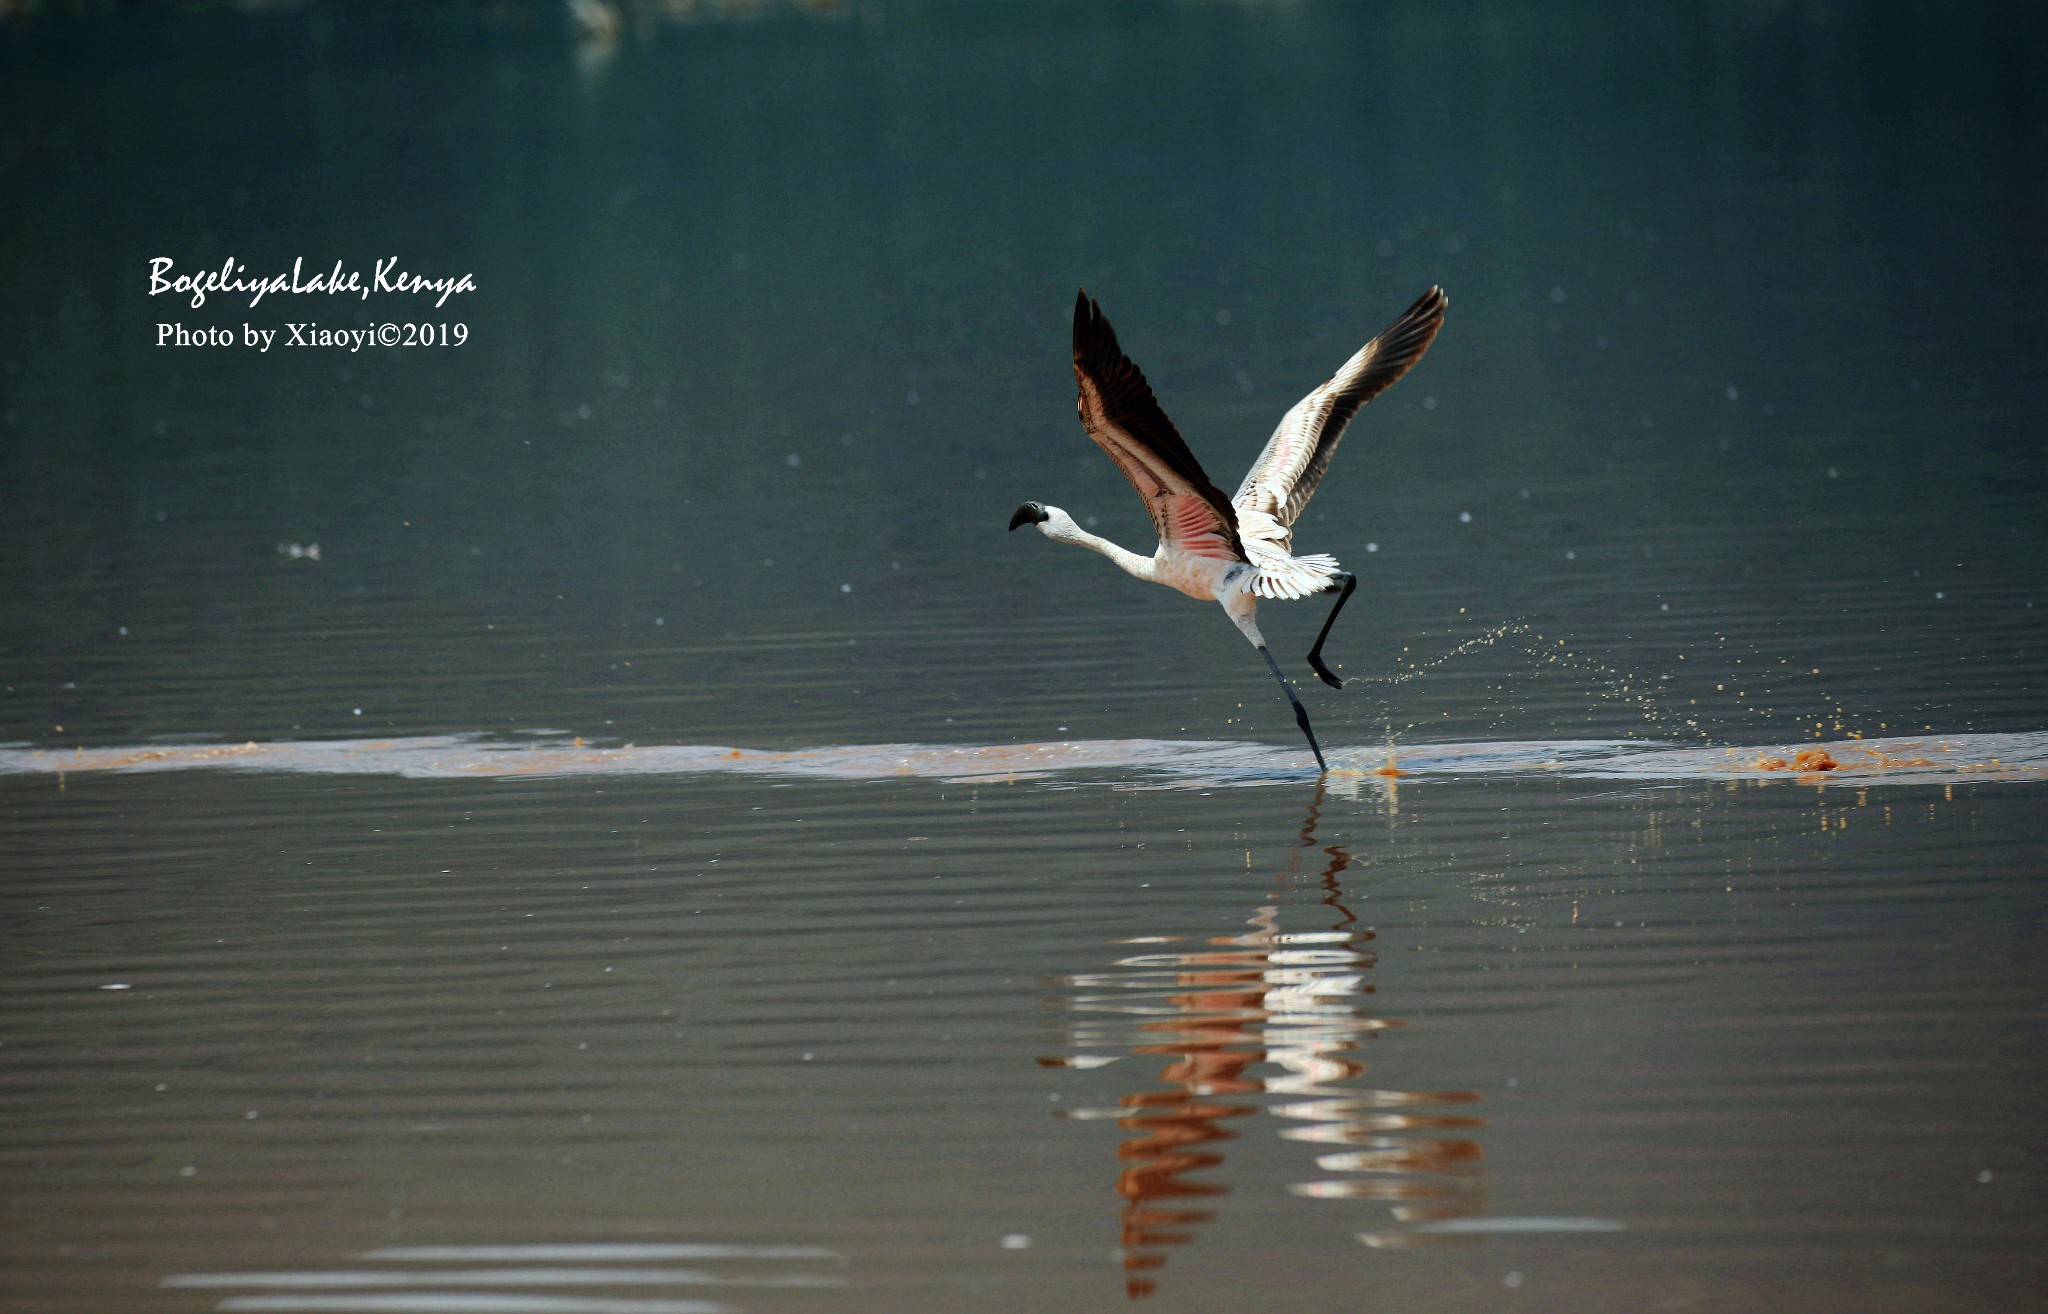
1010;287;1450;772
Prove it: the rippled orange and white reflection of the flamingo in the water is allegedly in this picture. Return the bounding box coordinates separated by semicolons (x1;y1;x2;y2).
1038;788;1485;1298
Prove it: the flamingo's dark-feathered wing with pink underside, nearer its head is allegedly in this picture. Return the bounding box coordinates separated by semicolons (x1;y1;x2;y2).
1073;289;1245;561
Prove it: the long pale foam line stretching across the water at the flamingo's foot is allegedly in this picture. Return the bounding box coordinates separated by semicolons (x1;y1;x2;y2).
0;731;2048;788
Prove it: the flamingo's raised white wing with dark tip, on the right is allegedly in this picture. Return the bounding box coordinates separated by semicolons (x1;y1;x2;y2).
1231;287;1450;553
